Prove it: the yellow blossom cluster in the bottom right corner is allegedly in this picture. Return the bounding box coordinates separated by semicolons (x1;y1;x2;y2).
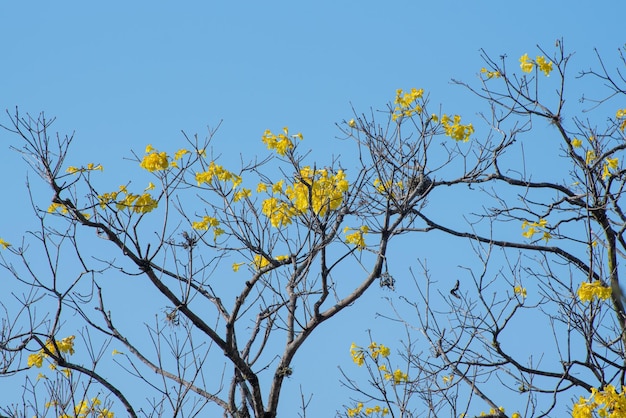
572;385;626;418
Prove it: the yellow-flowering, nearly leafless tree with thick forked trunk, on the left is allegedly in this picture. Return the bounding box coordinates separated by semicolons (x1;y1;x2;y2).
1;80;470;417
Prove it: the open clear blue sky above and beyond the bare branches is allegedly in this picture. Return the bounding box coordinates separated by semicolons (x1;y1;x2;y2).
0;0;626;417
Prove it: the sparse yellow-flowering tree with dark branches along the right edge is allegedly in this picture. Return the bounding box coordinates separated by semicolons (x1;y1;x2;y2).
344;41;626;418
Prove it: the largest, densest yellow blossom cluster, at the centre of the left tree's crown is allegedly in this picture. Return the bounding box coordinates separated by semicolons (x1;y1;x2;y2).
257;166;349;227
